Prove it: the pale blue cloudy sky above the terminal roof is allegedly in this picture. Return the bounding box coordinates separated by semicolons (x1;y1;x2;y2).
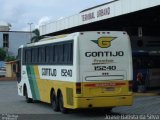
0;0;111;31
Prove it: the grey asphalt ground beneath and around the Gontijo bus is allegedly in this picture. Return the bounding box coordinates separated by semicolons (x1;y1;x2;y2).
0;81;160;120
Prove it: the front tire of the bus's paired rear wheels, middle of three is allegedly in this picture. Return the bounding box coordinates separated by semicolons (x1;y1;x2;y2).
51;91;59;112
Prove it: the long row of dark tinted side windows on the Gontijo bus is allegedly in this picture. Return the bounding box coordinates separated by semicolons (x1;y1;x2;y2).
23;41;73;65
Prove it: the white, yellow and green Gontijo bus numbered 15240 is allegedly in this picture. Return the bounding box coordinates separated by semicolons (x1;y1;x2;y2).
15;31;133;113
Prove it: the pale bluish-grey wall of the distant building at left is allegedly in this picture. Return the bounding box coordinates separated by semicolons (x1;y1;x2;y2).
0;31;31;57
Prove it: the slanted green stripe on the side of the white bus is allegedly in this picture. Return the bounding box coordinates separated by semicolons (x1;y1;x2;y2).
26;65;40;100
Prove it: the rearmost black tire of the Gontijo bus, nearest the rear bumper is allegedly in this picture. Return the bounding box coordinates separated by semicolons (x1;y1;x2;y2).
58;92;68;114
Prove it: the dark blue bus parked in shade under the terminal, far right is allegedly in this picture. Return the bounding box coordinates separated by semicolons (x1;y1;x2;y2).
133;51;160;91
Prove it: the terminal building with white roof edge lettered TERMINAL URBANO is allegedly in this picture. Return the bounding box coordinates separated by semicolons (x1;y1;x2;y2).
39;0;160;88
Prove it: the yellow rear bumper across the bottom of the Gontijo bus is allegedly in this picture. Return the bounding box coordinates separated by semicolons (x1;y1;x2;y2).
74;96;133;109
